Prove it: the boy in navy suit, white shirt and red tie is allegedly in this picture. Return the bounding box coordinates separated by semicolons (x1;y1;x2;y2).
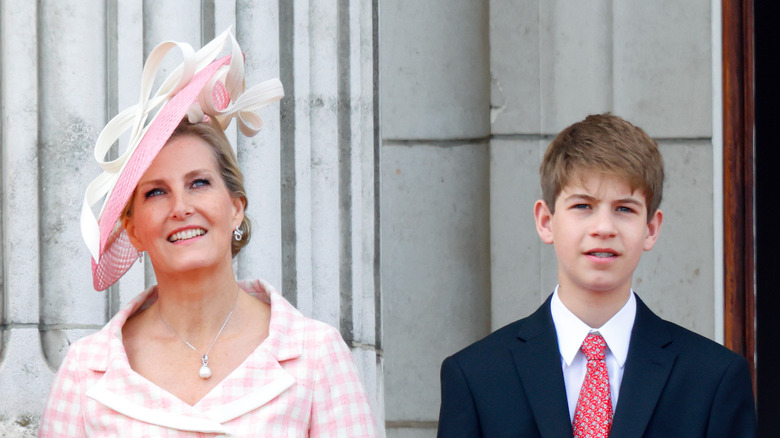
439;114;756;438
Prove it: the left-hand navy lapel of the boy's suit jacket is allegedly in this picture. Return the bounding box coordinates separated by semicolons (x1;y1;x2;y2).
511;298;572;438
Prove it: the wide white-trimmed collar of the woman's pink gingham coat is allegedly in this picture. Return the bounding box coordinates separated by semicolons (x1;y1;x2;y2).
87;280;304;433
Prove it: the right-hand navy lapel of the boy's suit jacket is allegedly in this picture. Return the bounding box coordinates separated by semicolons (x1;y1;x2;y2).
610;297;676;438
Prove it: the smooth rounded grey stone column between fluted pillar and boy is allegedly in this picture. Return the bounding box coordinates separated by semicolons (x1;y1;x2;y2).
380;0;490;438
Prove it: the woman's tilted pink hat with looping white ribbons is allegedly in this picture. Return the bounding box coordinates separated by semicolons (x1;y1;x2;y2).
81;30;284;290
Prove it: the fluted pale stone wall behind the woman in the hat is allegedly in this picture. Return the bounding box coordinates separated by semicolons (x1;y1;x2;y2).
0;0;384;436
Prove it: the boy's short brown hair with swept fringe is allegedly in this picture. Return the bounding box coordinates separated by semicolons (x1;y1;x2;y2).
539;113;664;221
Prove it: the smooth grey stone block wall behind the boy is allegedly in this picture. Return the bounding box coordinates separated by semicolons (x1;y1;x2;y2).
380;0;722;437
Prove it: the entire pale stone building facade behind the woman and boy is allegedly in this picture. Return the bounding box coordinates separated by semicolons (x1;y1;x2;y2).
0;0;723;438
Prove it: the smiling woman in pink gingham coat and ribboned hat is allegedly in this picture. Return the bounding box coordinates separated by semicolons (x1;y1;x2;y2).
39;33;375;437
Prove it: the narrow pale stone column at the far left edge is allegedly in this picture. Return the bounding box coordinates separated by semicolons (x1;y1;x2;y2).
0;2;52;436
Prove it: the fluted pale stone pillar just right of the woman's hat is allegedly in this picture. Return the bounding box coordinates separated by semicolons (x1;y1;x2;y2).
272;0;384;426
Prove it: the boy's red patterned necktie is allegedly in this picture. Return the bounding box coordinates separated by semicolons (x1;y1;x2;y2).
574;333;612;438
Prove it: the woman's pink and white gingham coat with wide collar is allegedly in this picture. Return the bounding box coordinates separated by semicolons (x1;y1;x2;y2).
38;281;375;437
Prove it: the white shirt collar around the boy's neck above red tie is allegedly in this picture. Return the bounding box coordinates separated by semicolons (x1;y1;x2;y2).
550;286;636;368
